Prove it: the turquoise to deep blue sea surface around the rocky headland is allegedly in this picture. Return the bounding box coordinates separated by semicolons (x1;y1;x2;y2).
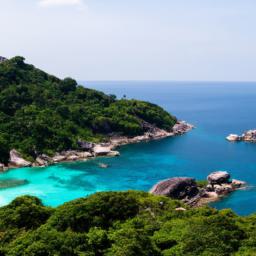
0;81;256;215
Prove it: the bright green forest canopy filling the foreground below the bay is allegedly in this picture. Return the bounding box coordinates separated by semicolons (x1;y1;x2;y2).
0;191;256;256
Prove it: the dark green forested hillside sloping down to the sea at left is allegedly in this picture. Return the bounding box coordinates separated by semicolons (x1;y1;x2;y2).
0;57;177;163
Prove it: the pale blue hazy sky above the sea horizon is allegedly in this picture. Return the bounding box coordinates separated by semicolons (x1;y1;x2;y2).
0;0;256;81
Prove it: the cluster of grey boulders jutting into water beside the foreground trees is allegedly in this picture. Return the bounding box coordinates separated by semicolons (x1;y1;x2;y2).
150;171;246;207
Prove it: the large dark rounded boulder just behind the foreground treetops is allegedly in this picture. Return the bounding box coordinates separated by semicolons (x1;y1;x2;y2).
150;177;199;199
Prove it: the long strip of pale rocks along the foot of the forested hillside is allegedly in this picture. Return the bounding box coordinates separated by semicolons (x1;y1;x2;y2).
0;121;194;171
